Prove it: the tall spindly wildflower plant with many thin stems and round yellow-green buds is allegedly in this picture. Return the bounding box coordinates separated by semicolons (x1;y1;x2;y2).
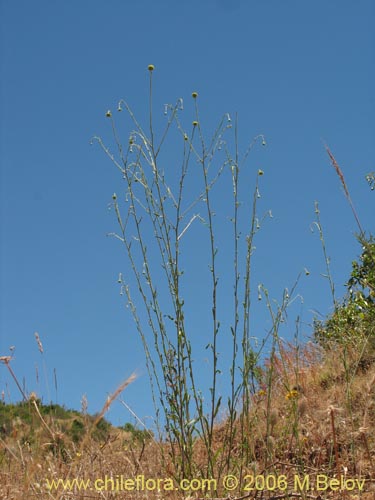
94;65;277;478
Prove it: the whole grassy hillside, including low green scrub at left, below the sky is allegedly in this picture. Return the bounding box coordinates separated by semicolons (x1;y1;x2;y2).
0;343;375;499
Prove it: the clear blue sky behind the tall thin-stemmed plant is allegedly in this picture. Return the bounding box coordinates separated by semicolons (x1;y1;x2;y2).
0;0;375;430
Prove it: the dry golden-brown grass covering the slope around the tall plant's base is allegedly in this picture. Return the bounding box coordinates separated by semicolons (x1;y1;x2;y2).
0;344;375;500
